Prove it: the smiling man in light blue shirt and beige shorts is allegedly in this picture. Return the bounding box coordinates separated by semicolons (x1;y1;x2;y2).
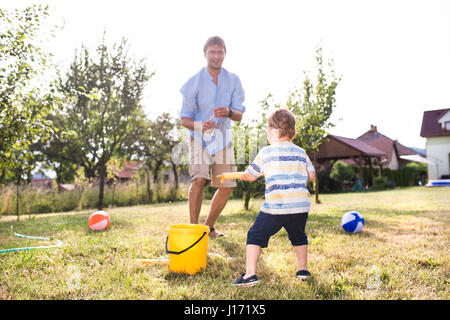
180;37;245;237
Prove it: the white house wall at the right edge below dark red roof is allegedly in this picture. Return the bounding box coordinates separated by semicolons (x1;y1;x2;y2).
425;136;450;179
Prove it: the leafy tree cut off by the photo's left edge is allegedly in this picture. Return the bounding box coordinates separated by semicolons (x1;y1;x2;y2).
0;5;57;183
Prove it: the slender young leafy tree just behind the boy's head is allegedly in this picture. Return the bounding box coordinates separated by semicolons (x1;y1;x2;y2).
286;47;340;203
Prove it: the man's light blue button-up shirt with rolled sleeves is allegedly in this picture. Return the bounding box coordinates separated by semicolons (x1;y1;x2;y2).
180;67;245;155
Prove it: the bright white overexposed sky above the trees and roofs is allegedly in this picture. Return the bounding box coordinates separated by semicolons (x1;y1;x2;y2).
0;0;450;148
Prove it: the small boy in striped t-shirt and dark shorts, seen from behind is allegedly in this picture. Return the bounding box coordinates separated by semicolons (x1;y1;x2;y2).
233;109;315;286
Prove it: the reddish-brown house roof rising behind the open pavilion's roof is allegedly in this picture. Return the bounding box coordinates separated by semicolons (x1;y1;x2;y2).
356;125;417;163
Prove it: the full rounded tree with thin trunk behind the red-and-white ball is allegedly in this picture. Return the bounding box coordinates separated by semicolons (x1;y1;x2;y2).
60;38;154;209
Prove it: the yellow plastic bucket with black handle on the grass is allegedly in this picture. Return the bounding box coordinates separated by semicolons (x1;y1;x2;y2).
166;224;209;274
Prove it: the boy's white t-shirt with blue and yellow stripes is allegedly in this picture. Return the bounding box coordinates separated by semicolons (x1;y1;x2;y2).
246;141;314;214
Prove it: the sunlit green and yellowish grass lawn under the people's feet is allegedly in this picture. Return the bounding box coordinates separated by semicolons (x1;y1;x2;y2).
0;187;450;300
